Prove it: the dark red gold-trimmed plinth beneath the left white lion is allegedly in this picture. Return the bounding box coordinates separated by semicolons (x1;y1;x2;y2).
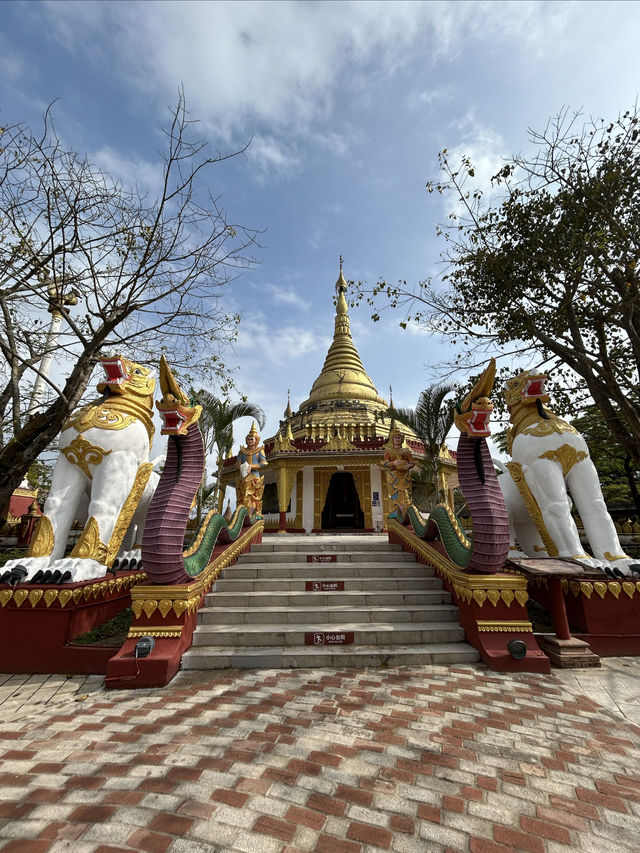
0;573;140;675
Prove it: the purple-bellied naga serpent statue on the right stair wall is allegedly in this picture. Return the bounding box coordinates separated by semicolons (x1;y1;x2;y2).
407;359;509;574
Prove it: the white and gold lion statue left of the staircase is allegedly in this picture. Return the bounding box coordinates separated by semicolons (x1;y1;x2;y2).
5;356;164;581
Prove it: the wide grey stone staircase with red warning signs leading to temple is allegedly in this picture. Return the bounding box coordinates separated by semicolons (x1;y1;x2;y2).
182;534;479;670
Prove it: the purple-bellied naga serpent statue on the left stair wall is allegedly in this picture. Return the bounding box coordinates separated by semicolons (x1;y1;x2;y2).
142;356;255;584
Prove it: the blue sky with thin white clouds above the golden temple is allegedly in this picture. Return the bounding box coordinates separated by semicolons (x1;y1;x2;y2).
0;0;640;460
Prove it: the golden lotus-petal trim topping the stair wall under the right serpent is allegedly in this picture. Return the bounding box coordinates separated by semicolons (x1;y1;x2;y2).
387;518;529;607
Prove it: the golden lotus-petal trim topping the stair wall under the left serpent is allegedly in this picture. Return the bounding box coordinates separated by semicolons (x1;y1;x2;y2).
131;521;264;620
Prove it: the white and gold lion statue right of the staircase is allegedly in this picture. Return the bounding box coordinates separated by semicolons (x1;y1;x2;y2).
498;371;640;575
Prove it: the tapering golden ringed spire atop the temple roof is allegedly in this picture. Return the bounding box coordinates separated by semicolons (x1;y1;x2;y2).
300;256;387;409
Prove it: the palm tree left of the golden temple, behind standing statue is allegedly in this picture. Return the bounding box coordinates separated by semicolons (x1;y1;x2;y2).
192;389;266;525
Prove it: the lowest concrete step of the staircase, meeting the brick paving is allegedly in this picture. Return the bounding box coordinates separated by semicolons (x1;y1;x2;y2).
182;643;480;668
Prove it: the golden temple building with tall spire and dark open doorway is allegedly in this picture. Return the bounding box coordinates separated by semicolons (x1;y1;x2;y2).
222;264;457;533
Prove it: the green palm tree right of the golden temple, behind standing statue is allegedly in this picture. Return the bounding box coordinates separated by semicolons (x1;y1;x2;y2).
387;384;458;504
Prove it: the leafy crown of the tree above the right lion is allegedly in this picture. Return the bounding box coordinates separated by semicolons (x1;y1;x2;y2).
355;108;640;466
